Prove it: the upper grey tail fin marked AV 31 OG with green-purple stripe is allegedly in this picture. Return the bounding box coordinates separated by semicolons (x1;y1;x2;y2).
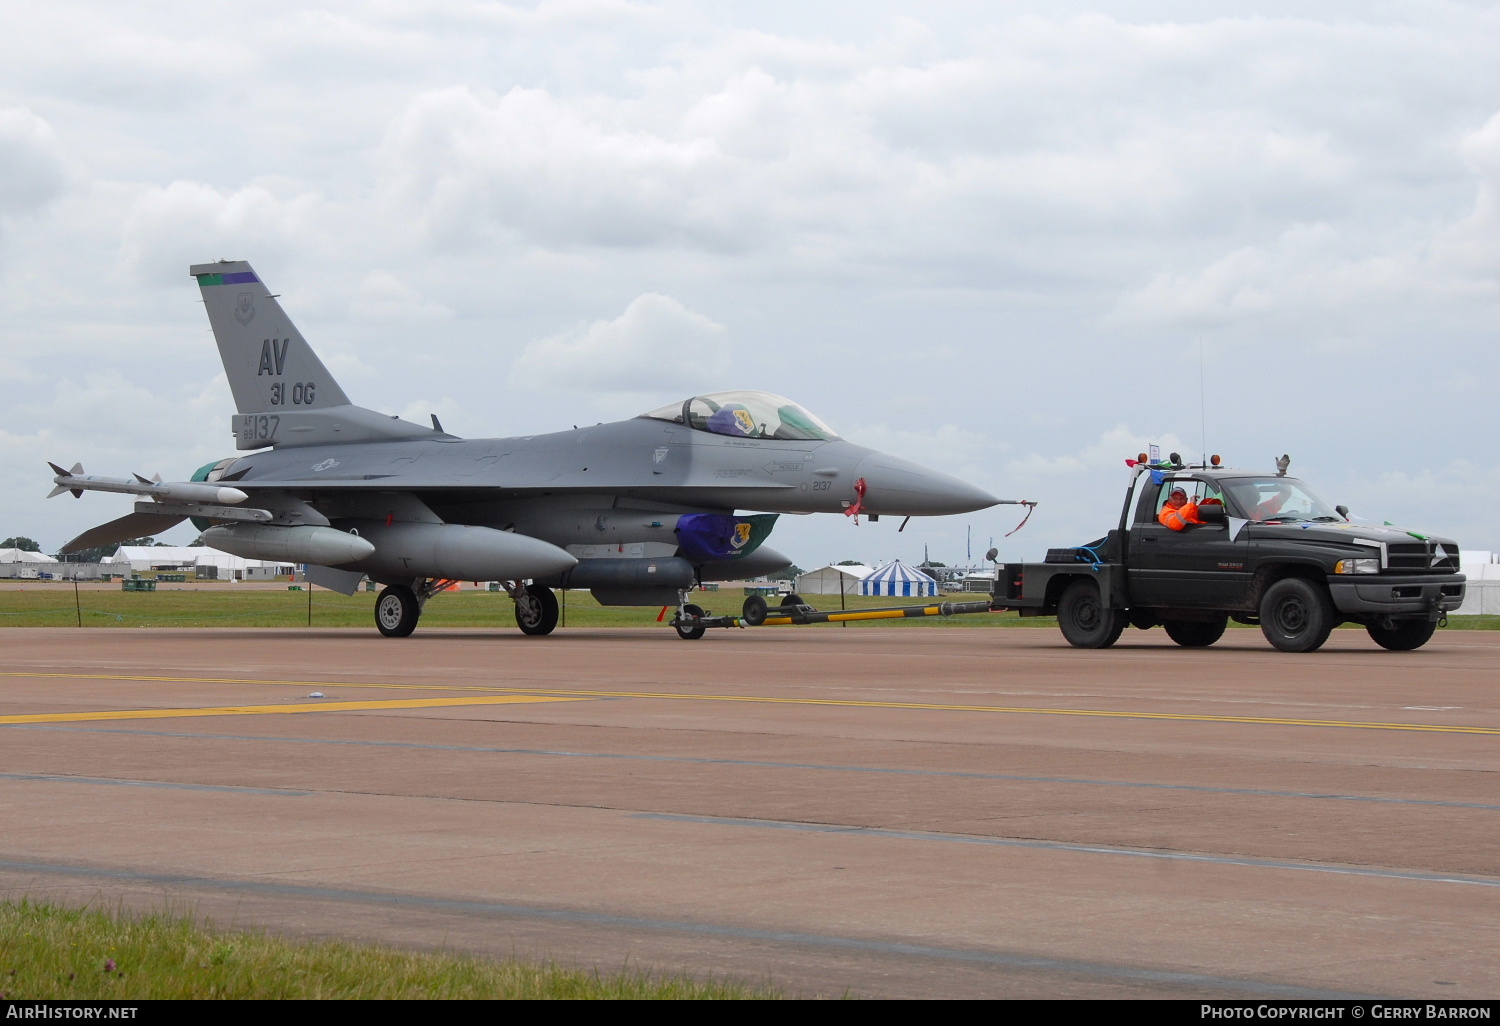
189;260;350;414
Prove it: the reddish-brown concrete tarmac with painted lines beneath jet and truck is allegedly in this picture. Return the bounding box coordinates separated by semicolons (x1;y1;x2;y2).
0;627;1500;999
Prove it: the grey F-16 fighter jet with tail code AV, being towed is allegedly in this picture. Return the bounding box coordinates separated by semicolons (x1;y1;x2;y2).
53;261;999;638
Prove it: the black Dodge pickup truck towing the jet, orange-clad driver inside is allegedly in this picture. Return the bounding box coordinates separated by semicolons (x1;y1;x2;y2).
992;456;1464;653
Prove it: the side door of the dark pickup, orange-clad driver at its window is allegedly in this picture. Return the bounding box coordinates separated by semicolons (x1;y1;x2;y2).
1130;479;1250;609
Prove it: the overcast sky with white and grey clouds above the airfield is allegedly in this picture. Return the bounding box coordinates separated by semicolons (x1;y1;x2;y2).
0;0;1500;567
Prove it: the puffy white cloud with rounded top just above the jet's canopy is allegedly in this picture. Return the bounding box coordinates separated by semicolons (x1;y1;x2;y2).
510;293;731;398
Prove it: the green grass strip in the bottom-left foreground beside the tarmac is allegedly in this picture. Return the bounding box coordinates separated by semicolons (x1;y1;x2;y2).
0;900;780;1001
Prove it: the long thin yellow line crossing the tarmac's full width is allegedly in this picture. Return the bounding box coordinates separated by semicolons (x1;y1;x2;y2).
0;671;1500;735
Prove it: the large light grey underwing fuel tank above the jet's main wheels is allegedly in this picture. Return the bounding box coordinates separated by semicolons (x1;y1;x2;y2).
343;521;578;581
